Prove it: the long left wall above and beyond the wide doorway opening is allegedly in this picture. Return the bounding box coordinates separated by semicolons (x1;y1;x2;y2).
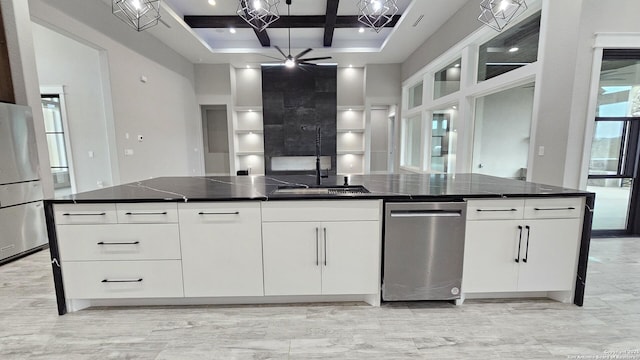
29;0;204;183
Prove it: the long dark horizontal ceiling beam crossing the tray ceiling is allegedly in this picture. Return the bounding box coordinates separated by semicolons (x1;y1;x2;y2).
184;15;401;32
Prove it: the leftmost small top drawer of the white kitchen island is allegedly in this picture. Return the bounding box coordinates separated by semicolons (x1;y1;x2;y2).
54;204;118;225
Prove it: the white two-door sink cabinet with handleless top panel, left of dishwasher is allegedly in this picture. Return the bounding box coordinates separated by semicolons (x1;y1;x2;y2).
262;200;381;295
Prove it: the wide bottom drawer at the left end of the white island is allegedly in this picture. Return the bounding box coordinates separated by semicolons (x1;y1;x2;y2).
62;260;184;299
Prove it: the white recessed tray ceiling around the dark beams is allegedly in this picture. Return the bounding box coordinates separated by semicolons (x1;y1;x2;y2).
146;0;474;67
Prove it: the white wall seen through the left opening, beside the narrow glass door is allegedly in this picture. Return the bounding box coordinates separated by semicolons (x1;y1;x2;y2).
33;24;113;192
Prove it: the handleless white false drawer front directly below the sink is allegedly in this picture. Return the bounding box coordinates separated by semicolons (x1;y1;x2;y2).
262;200;382;222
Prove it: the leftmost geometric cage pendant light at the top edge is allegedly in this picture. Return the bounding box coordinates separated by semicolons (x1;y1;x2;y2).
111;0;160;31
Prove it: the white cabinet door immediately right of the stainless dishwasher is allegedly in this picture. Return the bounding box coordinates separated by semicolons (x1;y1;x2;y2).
462;220;524;292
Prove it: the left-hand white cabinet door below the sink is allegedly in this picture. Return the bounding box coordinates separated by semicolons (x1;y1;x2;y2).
262;222;321;295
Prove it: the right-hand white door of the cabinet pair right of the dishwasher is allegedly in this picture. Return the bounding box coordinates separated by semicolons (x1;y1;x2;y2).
518;219;581;291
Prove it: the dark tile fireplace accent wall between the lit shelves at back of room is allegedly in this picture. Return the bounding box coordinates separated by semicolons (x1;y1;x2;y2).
262;66;338;175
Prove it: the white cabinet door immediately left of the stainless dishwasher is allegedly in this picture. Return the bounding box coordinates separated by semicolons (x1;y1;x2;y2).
321;221;381;295
